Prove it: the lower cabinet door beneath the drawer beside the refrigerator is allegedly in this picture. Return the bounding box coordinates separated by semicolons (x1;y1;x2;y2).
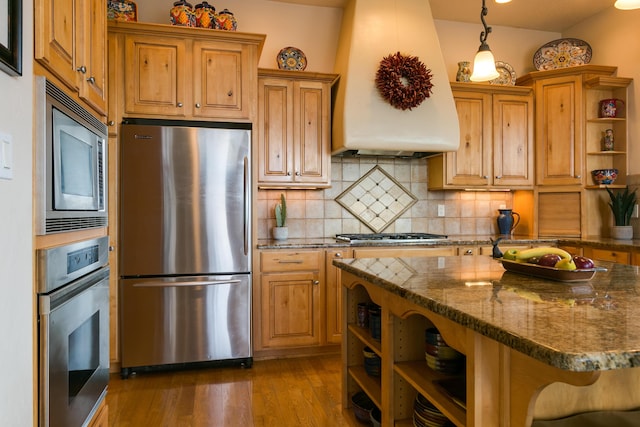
261;272;320;348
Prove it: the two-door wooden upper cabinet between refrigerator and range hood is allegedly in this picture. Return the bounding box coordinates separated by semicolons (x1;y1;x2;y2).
258;69;337;188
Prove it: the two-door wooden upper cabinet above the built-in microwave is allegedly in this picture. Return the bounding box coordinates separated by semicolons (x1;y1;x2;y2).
34;0;107;116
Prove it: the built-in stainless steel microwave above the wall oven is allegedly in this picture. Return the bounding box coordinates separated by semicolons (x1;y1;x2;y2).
34;76;108;235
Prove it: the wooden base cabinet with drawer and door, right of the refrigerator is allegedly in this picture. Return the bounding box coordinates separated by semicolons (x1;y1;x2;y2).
254;250;324;349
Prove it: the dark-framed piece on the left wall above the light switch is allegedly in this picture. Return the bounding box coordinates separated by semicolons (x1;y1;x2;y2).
0;0;22;76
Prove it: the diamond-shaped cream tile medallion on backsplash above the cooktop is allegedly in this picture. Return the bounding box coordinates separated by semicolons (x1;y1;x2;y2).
336;165;418;233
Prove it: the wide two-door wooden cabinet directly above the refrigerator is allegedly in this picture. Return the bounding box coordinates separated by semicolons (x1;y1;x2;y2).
109;21;265;121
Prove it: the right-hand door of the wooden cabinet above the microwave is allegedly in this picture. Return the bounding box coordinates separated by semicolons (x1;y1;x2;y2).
78;0;107;116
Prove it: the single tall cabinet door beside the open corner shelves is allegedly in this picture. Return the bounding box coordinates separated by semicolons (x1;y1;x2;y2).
535;76;582;185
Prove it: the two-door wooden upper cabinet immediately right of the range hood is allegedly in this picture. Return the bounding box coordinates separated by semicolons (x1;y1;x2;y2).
427;83;533;190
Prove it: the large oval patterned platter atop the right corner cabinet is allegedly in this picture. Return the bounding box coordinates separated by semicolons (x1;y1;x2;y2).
533;39;591;71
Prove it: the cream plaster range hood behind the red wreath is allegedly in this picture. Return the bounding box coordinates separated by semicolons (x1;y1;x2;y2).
332;0;460;157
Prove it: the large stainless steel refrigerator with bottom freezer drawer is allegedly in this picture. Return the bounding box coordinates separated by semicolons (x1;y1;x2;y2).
118;119;252;377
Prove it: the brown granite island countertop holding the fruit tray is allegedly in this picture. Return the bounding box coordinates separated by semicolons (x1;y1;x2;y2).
333;255;640;371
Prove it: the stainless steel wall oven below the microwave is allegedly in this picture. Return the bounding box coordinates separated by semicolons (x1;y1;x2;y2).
37;237;110;427
